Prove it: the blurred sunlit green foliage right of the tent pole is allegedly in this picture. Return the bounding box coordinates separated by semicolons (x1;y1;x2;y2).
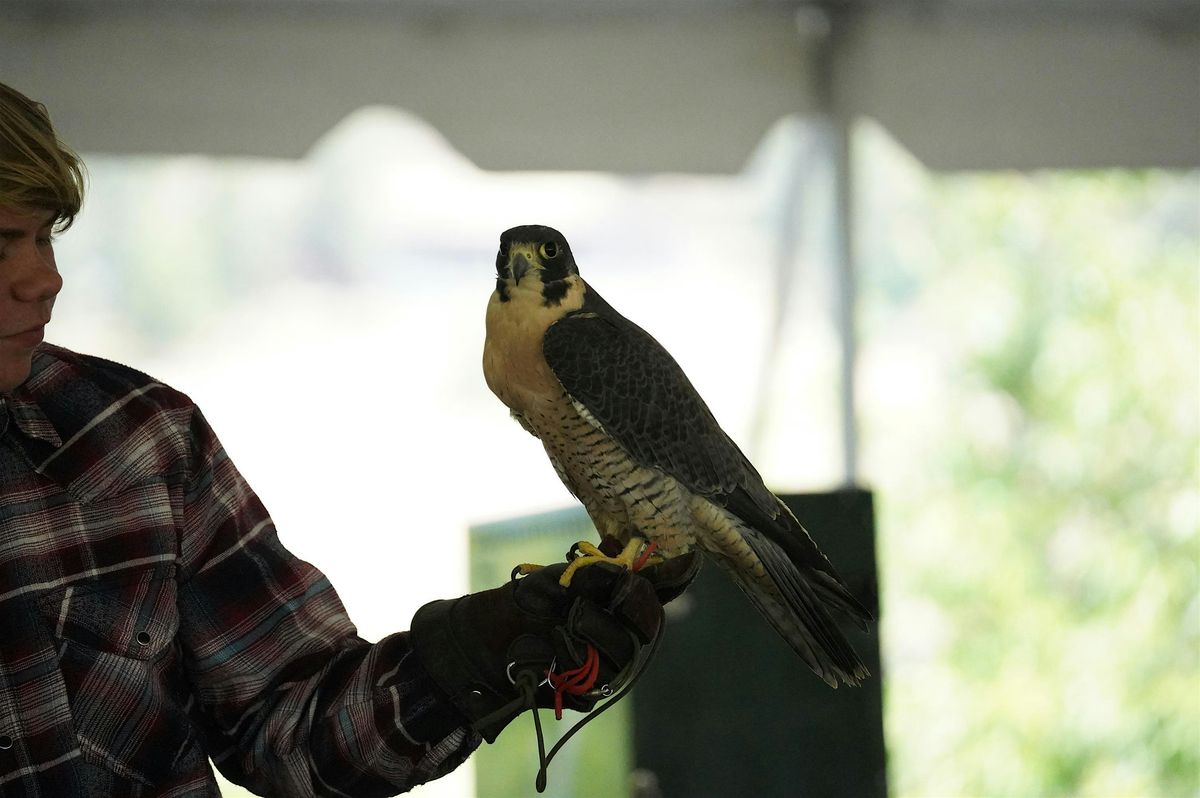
859;129;1200;797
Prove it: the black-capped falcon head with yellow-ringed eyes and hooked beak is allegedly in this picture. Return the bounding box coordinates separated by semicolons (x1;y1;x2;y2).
496;224;581;306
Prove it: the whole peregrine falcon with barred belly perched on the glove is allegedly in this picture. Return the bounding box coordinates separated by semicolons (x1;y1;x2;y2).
484;226;871;688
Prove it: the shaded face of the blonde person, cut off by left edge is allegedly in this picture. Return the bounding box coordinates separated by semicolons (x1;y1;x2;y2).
0;206;62;394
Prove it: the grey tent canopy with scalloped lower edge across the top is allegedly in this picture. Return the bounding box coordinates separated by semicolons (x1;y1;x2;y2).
0;0;1200;173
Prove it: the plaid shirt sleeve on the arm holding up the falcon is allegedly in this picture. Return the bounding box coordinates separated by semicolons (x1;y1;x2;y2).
179;410;480;798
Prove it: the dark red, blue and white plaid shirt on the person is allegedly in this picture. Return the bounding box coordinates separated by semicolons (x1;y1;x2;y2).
0;346;479;798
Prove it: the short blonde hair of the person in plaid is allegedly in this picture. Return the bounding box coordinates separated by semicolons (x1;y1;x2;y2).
0;83;84;233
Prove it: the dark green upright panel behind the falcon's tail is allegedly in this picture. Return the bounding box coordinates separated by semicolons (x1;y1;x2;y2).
631;490;887;798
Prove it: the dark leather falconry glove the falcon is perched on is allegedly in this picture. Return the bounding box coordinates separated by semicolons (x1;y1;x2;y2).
412;542;700;743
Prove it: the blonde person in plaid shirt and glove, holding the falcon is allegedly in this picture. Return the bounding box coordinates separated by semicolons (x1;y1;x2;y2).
0;84;695;798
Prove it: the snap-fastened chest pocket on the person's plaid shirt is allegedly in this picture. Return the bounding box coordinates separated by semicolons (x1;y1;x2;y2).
40;568;196;785
